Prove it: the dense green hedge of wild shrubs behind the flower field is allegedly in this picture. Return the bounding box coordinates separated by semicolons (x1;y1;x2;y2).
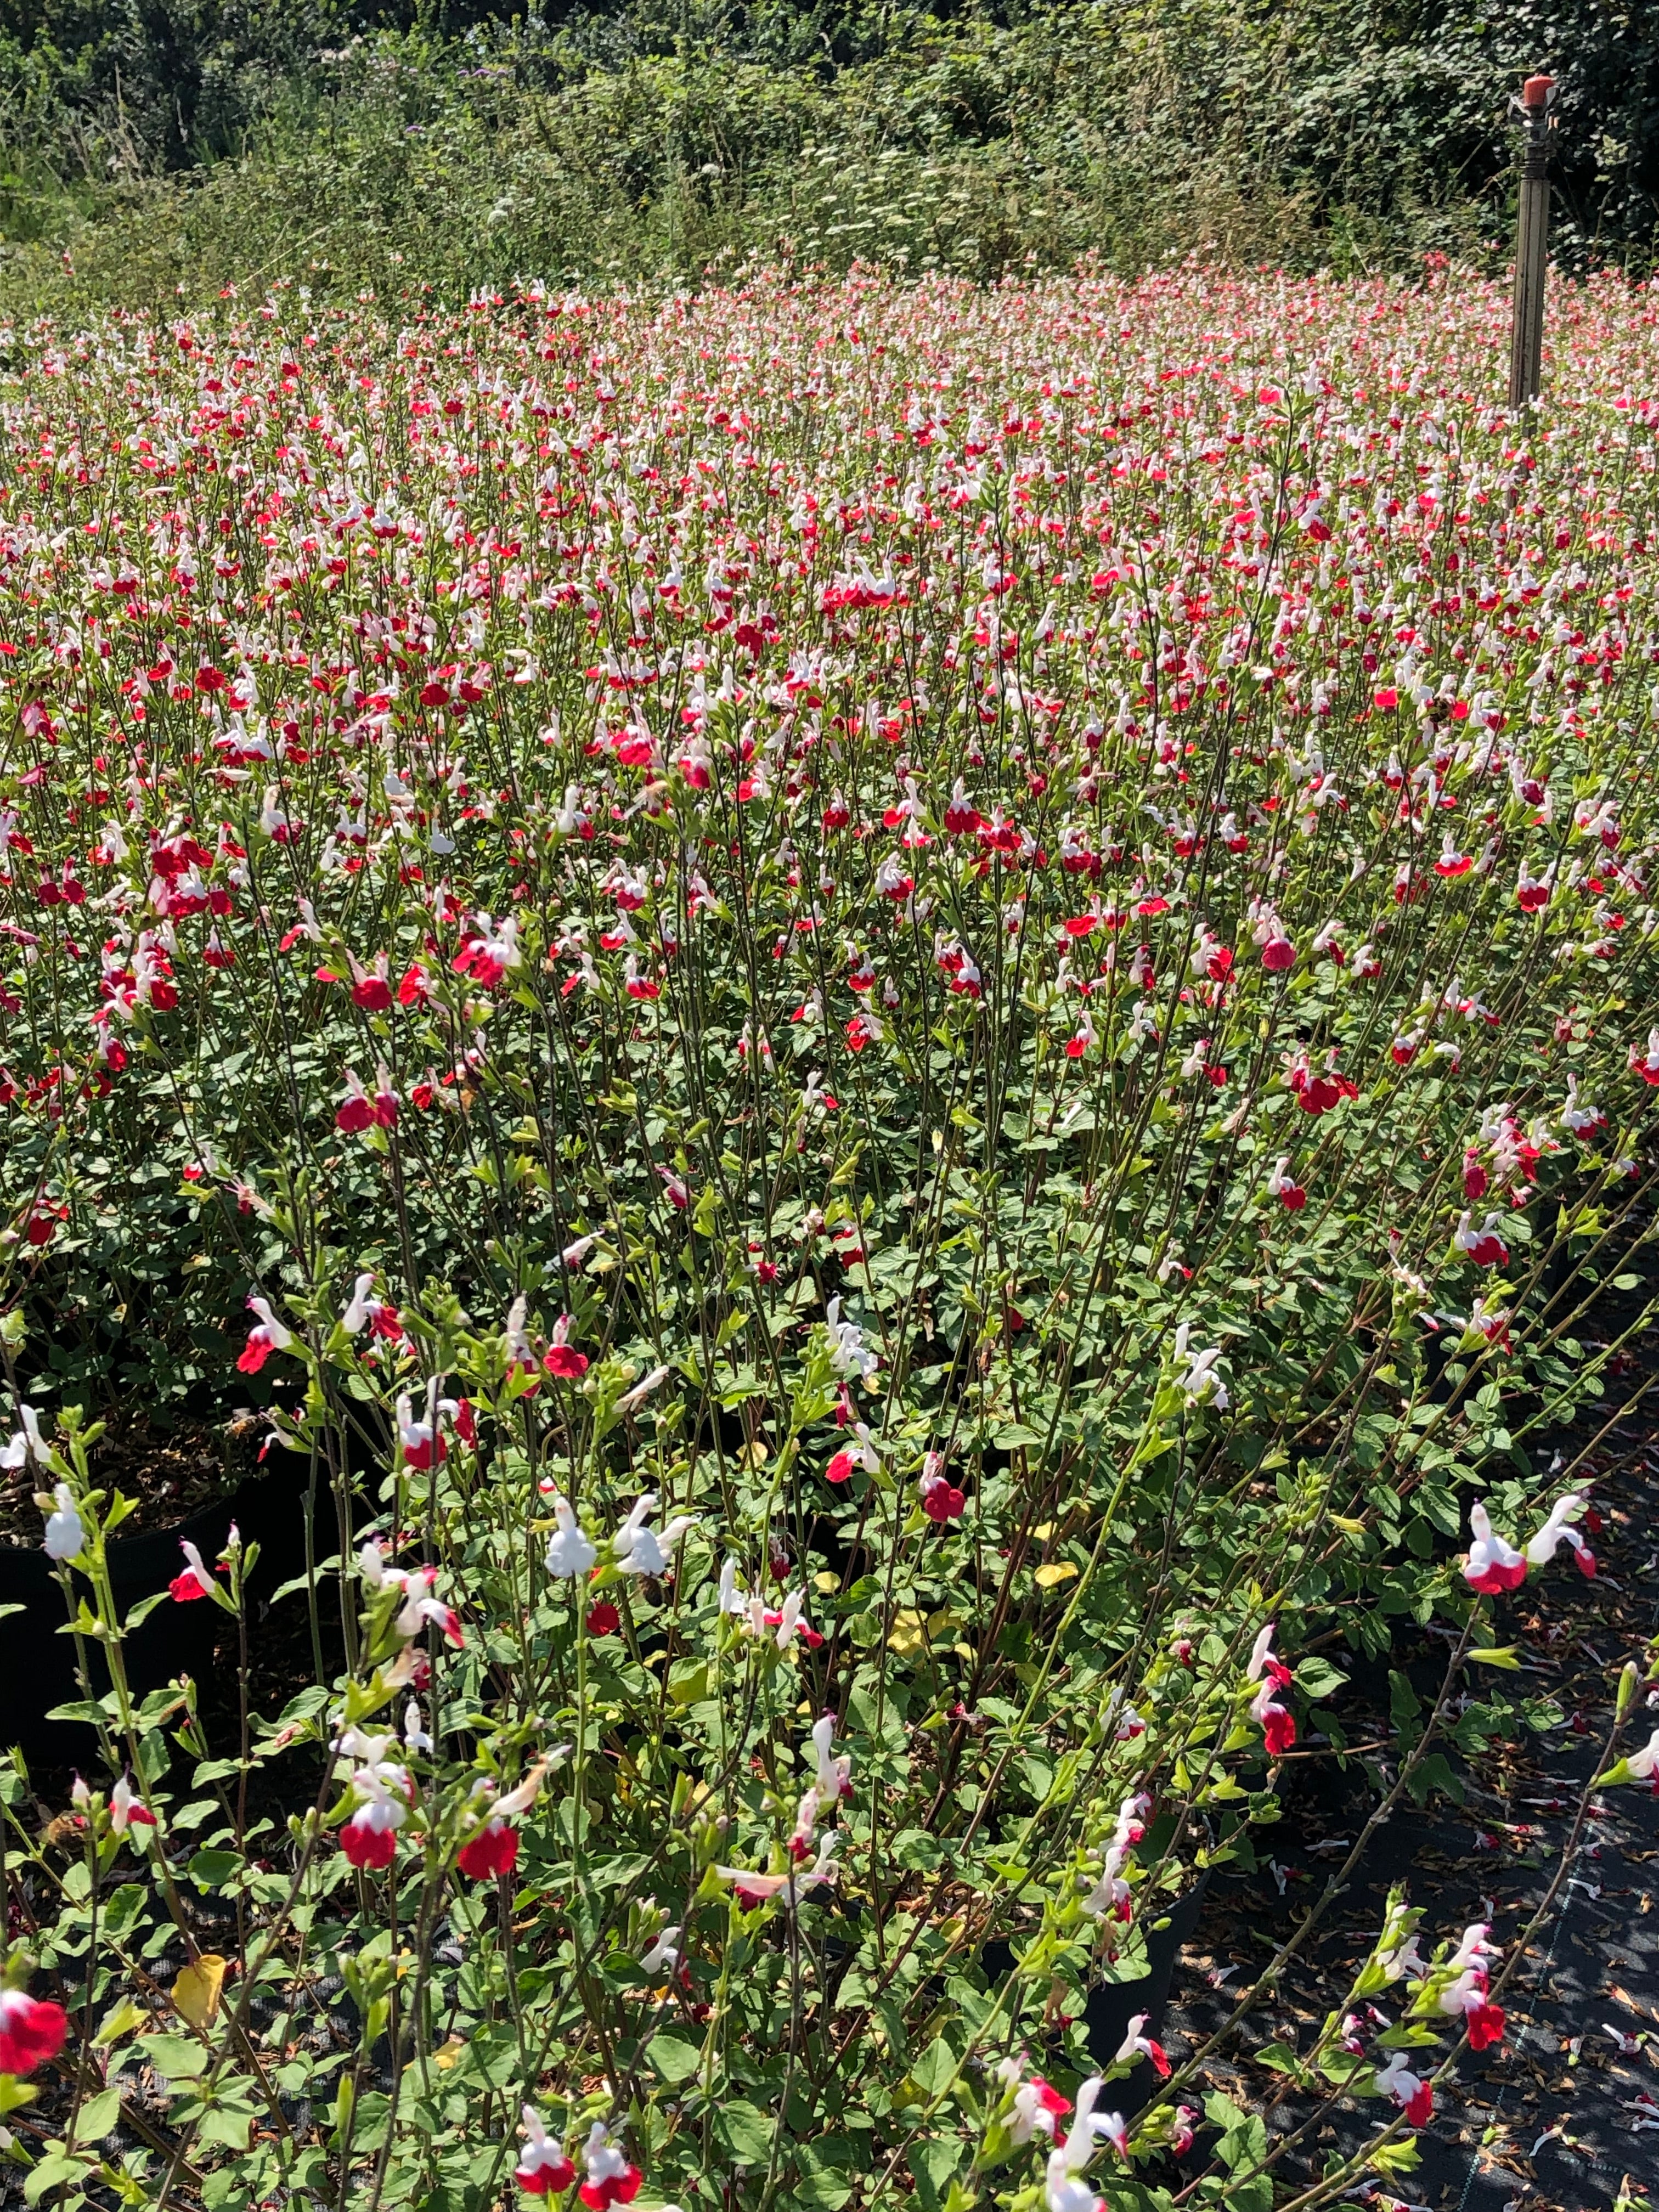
0;0;1659;305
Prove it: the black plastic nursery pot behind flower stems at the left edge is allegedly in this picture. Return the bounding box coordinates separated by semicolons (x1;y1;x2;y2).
0;1453;318;1765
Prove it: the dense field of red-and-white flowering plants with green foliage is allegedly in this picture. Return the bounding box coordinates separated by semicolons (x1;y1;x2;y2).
0;270;1659;2212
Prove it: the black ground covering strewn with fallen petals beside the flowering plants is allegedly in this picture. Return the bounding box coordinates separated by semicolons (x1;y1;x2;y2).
1164;1371;1659;2212
